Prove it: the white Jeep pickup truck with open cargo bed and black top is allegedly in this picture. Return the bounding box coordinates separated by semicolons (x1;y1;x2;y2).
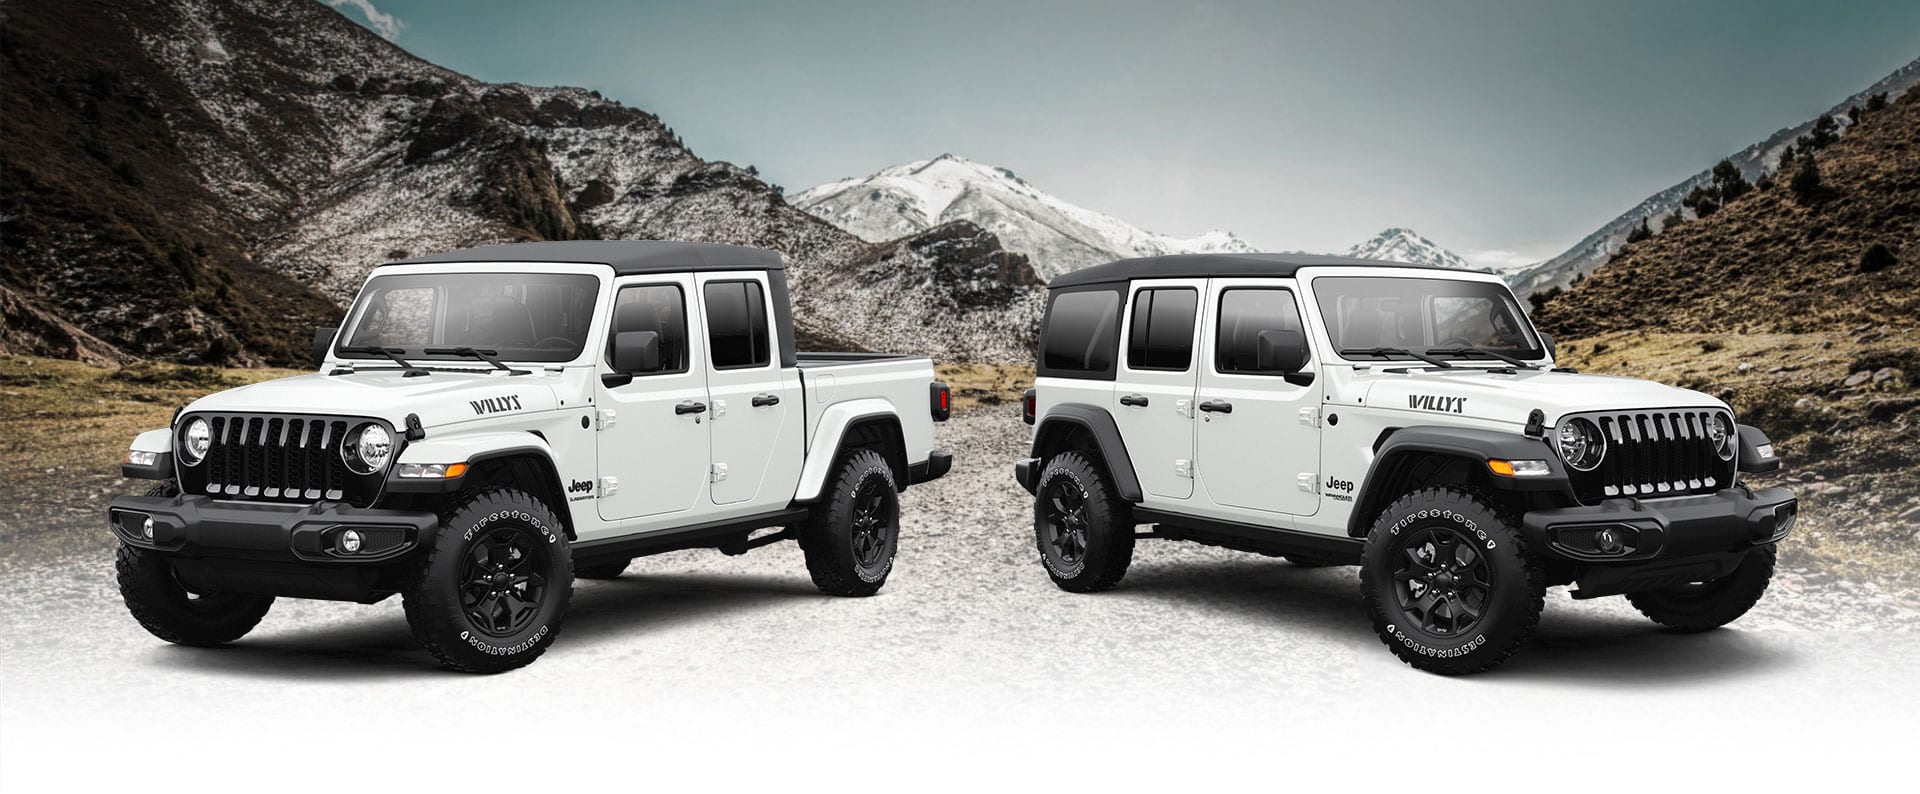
109;242;952;671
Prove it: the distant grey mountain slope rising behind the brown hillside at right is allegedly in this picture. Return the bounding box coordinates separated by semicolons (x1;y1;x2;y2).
1507;59;1920;297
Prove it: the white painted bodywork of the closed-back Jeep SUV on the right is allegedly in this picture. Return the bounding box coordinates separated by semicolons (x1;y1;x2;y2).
1035;267;1732;537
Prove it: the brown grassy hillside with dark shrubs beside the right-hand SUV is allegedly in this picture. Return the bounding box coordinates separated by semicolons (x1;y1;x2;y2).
1534;92;1920;552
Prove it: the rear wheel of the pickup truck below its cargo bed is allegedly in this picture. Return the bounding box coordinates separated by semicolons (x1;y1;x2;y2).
801;447;900;598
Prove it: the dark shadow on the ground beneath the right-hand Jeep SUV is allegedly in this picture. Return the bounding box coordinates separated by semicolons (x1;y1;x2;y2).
1114;558;1797;687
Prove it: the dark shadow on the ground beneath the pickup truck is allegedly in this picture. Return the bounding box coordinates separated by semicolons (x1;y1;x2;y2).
142;573;828;681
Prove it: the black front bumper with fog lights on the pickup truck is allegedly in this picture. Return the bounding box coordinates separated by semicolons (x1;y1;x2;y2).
108;497;440;600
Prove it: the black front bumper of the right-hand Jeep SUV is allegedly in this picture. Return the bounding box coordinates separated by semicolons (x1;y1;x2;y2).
1521;485;1799;598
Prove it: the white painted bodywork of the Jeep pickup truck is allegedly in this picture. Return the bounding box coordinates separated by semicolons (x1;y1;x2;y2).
132;263;933;541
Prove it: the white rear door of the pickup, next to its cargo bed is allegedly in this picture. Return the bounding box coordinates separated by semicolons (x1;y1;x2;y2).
699;270;804;506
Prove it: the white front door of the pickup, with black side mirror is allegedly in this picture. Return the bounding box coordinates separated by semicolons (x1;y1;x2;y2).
591;276;708;522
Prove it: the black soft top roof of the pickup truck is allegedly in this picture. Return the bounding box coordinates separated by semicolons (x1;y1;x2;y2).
388;240;785;276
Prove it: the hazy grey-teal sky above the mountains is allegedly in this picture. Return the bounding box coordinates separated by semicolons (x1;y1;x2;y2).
326;0;1920;265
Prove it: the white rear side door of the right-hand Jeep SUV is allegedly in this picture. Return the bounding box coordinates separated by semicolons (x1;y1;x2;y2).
1108;278;1206;499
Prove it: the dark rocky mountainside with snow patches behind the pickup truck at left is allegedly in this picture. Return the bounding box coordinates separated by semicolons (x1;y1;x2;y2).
0;0;1039;362
